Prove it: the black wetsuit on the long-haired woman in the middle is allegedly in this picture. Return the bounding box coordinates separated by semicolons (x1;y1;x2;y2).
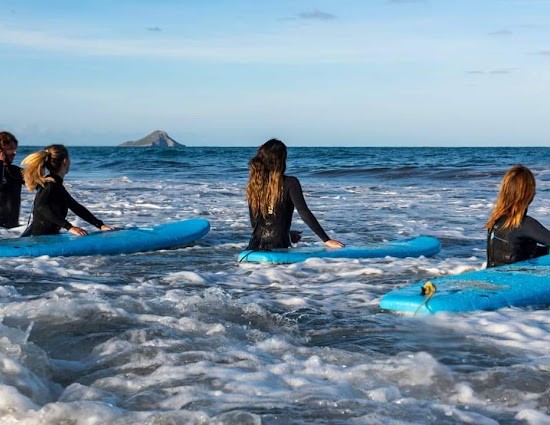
247;176;330;251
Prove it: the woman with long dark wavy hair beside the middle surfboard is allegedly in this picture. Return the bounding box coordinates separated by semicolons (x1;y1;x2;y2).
246;139;344;251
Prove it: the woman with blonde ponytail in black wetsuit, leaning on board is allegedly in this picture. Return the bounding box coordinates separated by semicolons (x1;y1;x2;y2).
21;145;113;236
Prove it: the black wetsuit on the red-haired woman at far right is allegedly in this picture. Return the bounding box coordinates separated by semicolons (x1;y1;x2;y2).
487;215;550;267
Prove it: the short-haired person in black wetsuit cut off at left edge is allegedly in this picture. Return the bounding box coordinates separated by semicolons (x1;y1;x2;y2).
0;131;23;229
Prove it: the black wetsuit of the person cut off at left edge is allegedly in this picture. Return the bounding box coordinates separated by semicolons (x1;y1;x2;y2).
0;161;23;229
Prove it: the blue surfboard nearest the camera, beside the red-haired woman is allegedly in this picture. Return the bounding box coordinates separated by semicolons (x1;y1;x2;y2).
380;255;550;314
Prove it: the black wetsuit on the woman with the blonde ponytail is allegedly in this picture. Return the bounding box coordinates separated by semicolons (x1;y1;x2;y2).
21;175;103;236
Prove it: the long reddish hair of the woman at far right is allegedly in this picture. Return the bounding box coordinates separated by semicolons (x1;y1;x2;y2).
485;165;536;230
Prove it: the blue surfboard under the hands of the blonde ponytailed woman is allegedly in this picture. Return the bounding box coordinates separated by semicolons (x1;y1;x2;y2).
0;218;210;257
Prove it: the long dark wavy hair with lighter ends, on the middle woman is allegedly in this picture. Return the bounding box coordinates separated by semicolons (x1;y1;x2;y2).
246;139;287;218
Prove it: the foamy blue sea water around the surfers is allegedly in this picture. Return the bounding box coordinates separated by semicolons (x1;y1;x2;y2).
0;147;550;425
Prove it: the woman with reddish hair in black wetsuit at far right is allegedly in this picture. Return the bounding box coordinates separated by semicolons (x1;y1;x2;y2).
485;165;550;268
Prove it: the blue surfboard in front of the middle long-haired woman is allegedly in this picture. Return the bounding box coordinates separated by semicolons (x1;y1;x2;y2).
238;236;441;264
